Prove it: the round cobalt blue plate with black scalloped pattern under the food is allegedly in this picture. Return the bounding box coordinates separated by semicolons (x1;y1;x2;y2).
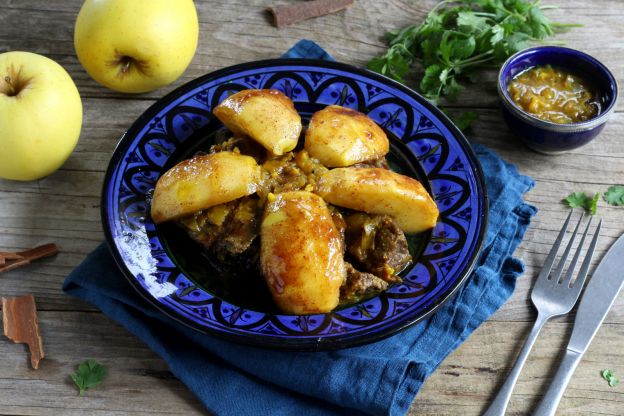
102;59;487;350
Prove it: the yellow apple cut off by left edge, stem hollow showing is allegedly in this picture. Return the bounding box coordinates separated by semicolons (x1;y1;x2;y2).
0;51;82;181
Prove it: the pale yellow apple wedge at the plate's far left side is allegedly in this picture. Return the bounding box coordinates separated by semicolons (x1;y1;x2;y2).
151;152;262;224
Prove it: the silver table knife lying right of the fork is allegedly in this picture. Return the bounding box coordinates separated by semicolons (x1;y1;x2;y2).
534;235;624;416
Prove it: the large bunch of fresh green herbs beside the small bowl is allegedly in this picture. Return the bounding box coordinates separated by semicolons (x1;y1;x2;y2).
368;0;578;109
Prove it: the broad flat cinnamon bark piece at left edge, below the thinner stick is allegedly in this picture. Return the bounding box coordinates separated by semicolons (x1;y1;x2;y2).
2;295;45;370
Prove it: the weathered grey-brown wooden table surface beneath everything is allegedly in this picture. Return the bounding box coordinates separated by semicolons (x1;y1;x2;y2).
0;0;624;415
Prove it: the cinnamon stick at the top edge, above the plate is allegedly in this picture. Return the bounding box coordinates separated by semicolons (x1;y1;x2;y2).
268;0;355;28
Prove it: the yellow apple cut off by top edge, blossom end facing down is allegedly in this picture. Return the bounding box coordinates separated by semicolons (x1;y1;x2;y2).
74;0;199;93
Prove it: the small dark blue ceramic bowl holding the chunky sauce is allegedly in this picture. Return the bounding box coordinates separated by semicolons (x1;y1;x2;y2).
498;46;618;154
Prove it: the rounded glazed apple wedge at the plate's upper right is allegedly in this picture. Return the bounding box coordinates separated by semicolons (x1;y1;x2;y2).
305;105;390;167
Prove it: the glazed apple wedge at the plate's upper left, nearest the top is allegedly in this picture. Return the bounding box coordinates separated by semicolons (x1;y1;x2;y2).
213;90;301;155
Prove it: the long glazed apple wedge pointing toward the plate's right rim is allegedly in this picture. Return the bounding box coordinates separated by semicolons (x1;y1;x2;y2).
317;168;439;233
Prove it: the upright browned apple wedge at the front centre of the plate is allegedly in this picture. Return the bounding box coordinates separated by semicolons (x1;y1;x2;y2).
260;191;347;314
